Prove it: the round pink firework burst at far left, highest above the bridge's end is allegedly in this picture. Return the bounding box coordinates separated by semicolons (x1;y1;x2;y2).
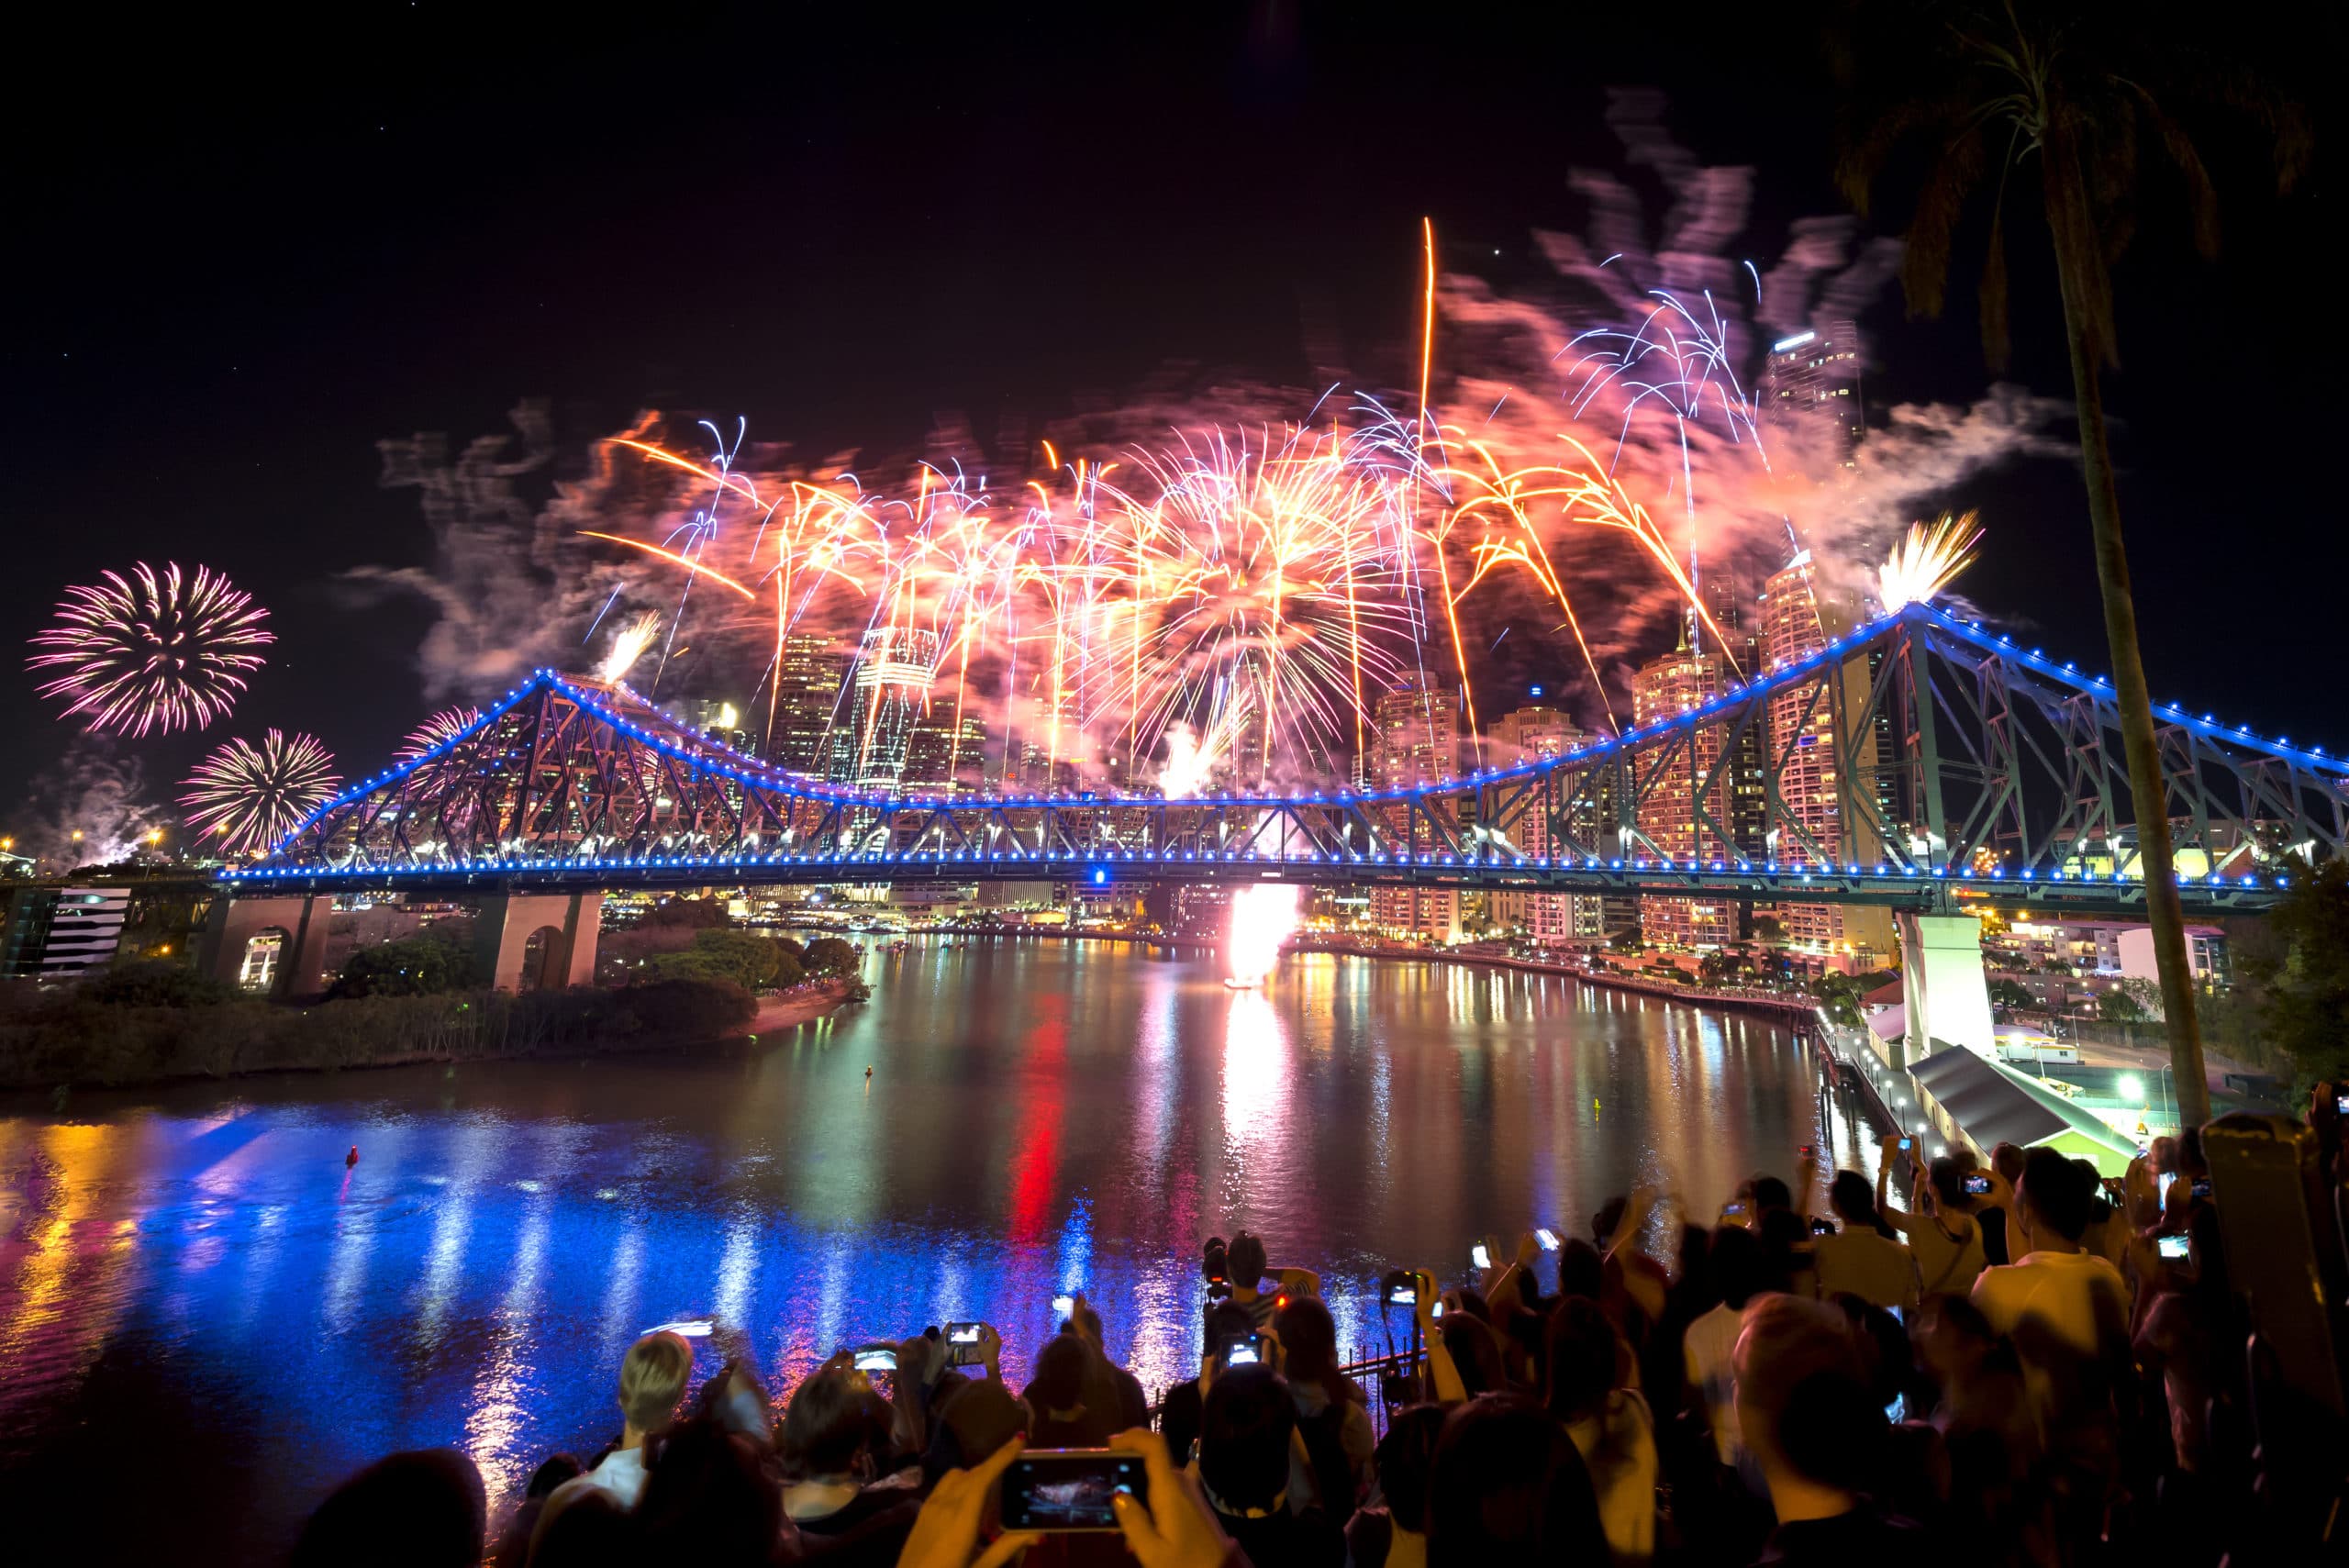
28;561;277;735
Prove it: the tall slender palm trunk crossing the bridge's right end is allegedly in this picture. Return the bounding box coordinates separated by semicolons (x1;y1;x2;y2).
2043;139;2210;1127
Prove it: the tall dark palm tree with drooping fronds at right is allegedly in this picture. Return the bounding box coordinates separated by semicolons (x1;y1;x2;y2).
1837;0;2307;1124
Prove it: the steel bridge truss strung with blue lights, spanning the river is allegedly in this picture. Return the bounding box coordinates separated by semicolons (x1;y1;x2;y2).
226;606;2349;913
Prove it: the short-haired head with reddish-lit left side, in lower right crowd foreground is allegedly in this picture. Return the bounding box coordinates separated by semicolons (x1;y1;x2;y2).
1733;1294;1884;1491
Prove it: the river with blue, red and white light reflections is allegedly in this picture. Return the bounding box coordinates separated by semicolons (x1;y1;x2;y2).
0;939;1875;1563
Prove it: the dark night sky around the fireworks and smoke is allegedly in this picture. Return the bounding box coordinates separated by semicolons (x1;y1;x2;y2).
0;3;2349;827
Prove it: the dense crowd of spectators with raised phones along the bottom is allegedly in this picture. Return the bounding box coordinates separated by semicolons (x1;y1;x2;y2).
296;1087;2342;1568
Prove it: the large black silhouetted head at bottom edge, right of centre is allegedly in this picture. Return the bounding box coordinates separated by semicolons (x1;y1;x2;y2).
1428;1395;1609;1568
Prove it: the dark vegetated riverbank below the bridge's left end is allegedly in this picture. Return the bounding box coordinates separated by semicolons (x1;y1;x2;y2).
0;970;863;1092
